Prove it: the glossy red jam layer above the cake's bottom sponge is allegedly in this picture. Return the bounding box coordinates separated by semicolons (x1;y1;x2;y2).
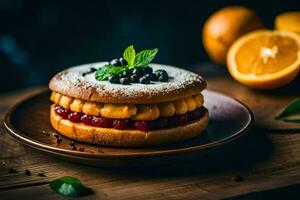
54;105;207;131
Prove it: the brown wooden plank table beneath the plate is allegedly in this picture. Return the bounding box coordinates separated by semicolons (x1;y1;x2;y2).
0;66;300;200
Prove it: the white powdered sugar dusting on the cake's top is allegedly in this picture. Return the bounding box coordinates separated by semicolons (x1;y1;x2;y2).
52;62;204;102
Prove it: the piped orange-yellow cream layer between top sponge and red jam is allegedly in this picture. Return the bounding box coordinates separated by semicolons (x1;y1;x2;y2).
50;92;204;120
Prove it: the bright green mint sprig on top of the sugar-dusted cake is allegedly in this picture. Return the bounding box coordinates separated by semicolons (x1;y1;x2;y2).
95;45;158;81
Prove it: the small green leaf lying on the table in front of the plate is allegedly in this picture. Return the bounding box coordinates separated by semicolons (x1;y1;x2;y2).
49;176;92;197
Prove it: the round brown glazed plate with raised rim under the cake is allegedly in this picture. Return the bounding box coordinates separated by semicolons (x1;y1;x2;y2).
4;90;253;166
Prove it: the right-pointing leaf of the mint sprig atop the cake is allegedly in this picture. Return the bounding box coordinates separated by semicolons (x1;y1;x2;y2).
134;48;158;67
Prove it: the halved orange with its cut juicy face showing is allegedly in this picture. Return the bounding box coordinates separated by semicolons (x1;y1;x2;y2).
227;30;300;89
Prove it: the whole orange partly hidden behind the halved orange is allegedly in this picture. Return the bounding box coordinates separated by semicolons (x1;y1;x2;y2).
202;6;264;64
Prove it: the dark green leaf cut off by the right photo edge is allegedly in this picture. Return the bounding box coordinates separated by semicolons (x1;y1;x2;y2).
275;98;300;123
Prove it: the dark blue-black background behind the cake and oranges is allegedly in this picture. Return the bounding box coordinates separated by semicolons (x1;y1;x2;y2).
0;0;300;92
